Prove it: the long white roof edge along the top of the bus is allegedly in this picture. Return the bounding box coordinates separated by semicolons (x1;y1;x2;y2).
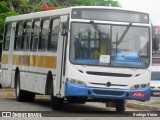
5;6;148;22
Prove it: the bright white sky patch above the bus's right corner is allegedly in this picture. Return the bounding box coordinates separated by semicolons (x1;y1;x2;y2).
117;0;160;25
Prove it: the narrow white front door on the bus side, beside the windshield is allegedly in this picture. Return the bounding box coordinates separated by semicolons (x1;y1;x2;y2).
54;15;69;97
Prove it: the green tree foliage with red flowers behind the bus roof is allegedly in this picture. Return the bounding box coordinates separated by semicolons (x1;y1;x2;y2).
0;0;120;55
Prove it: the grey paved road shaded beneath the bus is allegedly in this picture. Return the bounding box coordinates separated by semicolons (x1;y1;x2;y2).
0;97;137;116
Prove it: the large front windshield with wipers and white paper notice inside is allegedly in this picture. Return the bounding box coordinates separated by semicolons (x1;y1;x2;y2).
70;22;150;68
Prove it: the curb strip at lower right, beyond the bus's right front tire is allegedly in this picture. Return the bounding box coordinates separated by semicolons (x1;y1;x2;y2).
126;101;160;111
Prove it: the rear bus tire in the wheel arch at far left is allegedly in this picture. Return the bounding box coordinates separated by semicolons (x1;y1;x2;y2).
15;73;26;102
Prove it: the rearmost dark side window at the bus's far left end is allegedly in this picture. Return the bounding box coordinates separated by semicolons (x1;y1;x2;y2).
3;23;11;50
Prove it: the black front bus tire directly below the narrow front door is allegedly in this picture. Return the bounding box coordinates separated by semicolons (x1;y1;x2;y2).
51;81;63;110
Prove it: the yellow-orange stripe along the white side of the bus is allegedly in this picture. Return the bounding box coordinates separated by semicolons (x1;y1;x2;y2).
3;54;57;68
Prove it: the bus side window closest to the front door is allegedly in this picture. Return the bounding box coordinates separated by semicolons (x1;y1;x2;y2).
48;18;60;52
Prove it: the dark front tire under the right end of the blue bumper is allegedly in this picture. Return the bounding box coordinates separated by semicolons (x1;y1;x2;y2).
116;100;126;112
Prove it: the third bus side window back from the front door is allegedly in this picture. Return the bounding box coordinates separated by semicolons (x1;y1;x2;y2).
30;20;41;51
